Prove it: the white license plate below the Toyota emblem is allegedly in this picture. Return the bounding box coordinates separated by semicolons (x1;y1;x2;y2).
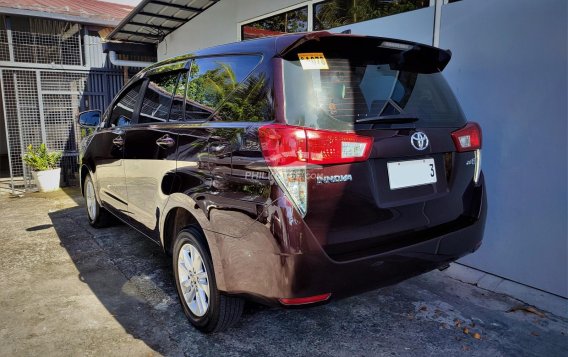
387;159;436;190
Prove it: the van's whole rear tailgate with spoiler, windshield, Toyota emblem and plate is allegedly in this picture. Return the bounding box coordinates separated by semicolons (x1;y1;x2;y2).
283;37;476;260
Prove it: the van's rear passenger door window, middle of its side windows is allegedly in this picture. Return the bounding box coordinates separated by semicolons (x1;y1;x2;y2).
138;72;179;123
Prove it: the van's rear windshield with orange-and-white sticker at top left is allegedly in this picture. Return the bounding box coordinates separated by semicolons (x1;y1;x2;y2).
283;57;465;130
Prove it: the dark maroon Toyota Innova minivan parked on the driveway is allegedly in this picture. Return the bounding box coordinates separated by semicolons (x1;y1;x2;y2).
79;32;487;332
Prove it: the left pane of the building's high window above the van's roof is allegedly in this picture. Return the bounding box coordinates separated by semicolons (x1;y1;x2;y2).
241;6;308;40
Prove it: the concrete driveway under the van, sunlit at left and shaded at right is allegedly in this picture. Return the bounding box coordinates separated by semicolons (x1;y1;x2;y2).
0;189;568;356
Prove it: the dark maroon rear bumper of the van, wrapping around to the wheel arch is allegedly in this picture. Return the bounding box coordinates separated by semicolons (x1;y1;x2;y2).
217;177;487;305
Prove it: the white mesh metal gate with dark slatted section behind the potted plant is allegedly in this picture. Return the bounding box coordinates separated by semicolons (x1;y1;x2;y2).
0;69;123;190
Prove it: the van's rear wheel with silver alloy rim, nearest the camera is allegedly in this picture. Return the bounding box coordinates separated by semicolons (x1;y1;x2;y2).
173;227;244;333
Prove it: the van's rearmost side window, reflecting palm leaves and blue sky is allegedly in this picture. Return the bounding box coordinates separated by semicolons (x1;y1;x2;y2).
185;55;266;121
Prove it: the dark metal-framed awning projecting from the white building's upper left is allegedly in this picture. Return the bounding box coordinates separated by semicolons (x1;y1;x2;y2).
107;0;219;44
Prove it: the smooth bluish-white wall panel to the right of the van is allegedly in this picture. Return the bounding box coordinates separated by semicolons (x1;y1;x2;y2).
440;0;568;297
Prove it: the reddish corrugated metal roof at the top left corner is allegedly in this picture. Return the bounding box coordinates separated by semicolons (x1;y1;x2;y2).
0;0;133;24
